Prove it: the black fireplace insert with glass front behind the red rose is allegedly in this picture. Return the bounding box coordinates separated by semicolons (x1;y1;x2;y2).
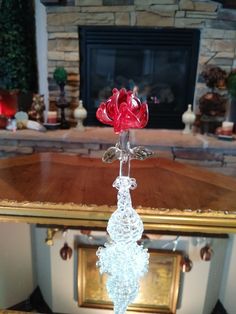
79;26;200;129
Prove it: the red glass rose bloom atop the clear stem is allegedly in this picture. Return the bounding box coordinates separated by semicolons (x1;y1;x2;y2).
96;88;148;133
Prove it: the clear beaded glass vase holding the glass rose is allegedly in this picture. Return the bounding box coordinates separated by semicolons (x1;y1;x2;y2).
97;176;149;314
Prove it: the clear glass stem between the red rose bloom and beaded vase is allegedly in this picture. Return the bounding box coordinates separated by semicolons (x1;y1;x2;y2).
119;131;130;177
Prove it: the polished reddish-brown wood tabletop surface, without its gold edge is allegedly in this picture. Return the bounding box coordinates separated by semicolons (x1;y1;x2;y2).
0;153;236;211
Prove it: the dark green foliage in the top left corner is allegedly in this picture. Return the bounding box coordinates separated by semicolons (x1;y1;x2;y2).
0;0;37;92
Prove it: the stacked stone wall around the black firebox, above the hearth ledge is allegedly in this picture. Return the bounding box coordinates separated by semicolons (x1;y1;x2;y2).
36;0;236;120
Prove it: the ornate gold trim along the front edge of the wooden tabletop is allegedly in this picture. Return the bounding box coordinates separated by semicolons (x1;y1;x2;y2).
0;200;236;233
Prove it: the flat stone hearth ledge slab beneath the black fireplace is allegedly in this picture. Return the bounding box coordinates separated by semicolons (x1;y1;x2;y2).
0;127;236;153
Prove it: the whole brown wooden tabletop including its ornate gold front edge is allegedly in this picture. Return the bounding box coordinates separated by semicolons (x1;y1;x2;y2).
0;153;236;232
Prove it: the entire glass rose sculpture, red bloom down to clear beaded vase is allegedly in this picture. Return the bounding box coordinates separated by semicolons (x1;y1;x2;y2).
96;89;152;314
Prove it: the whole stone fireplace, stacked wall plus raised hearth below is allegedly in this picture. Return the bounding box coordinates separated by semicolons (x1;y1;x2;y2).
0;0;236;169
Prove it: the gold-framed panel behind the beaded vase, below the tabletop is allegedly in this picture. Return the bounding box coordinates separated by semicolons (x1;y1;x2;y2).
78;247;181;314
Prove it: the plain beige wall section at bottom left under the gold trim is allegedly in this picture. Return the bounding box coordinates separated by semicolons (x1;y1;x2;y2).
0;223;35;308
